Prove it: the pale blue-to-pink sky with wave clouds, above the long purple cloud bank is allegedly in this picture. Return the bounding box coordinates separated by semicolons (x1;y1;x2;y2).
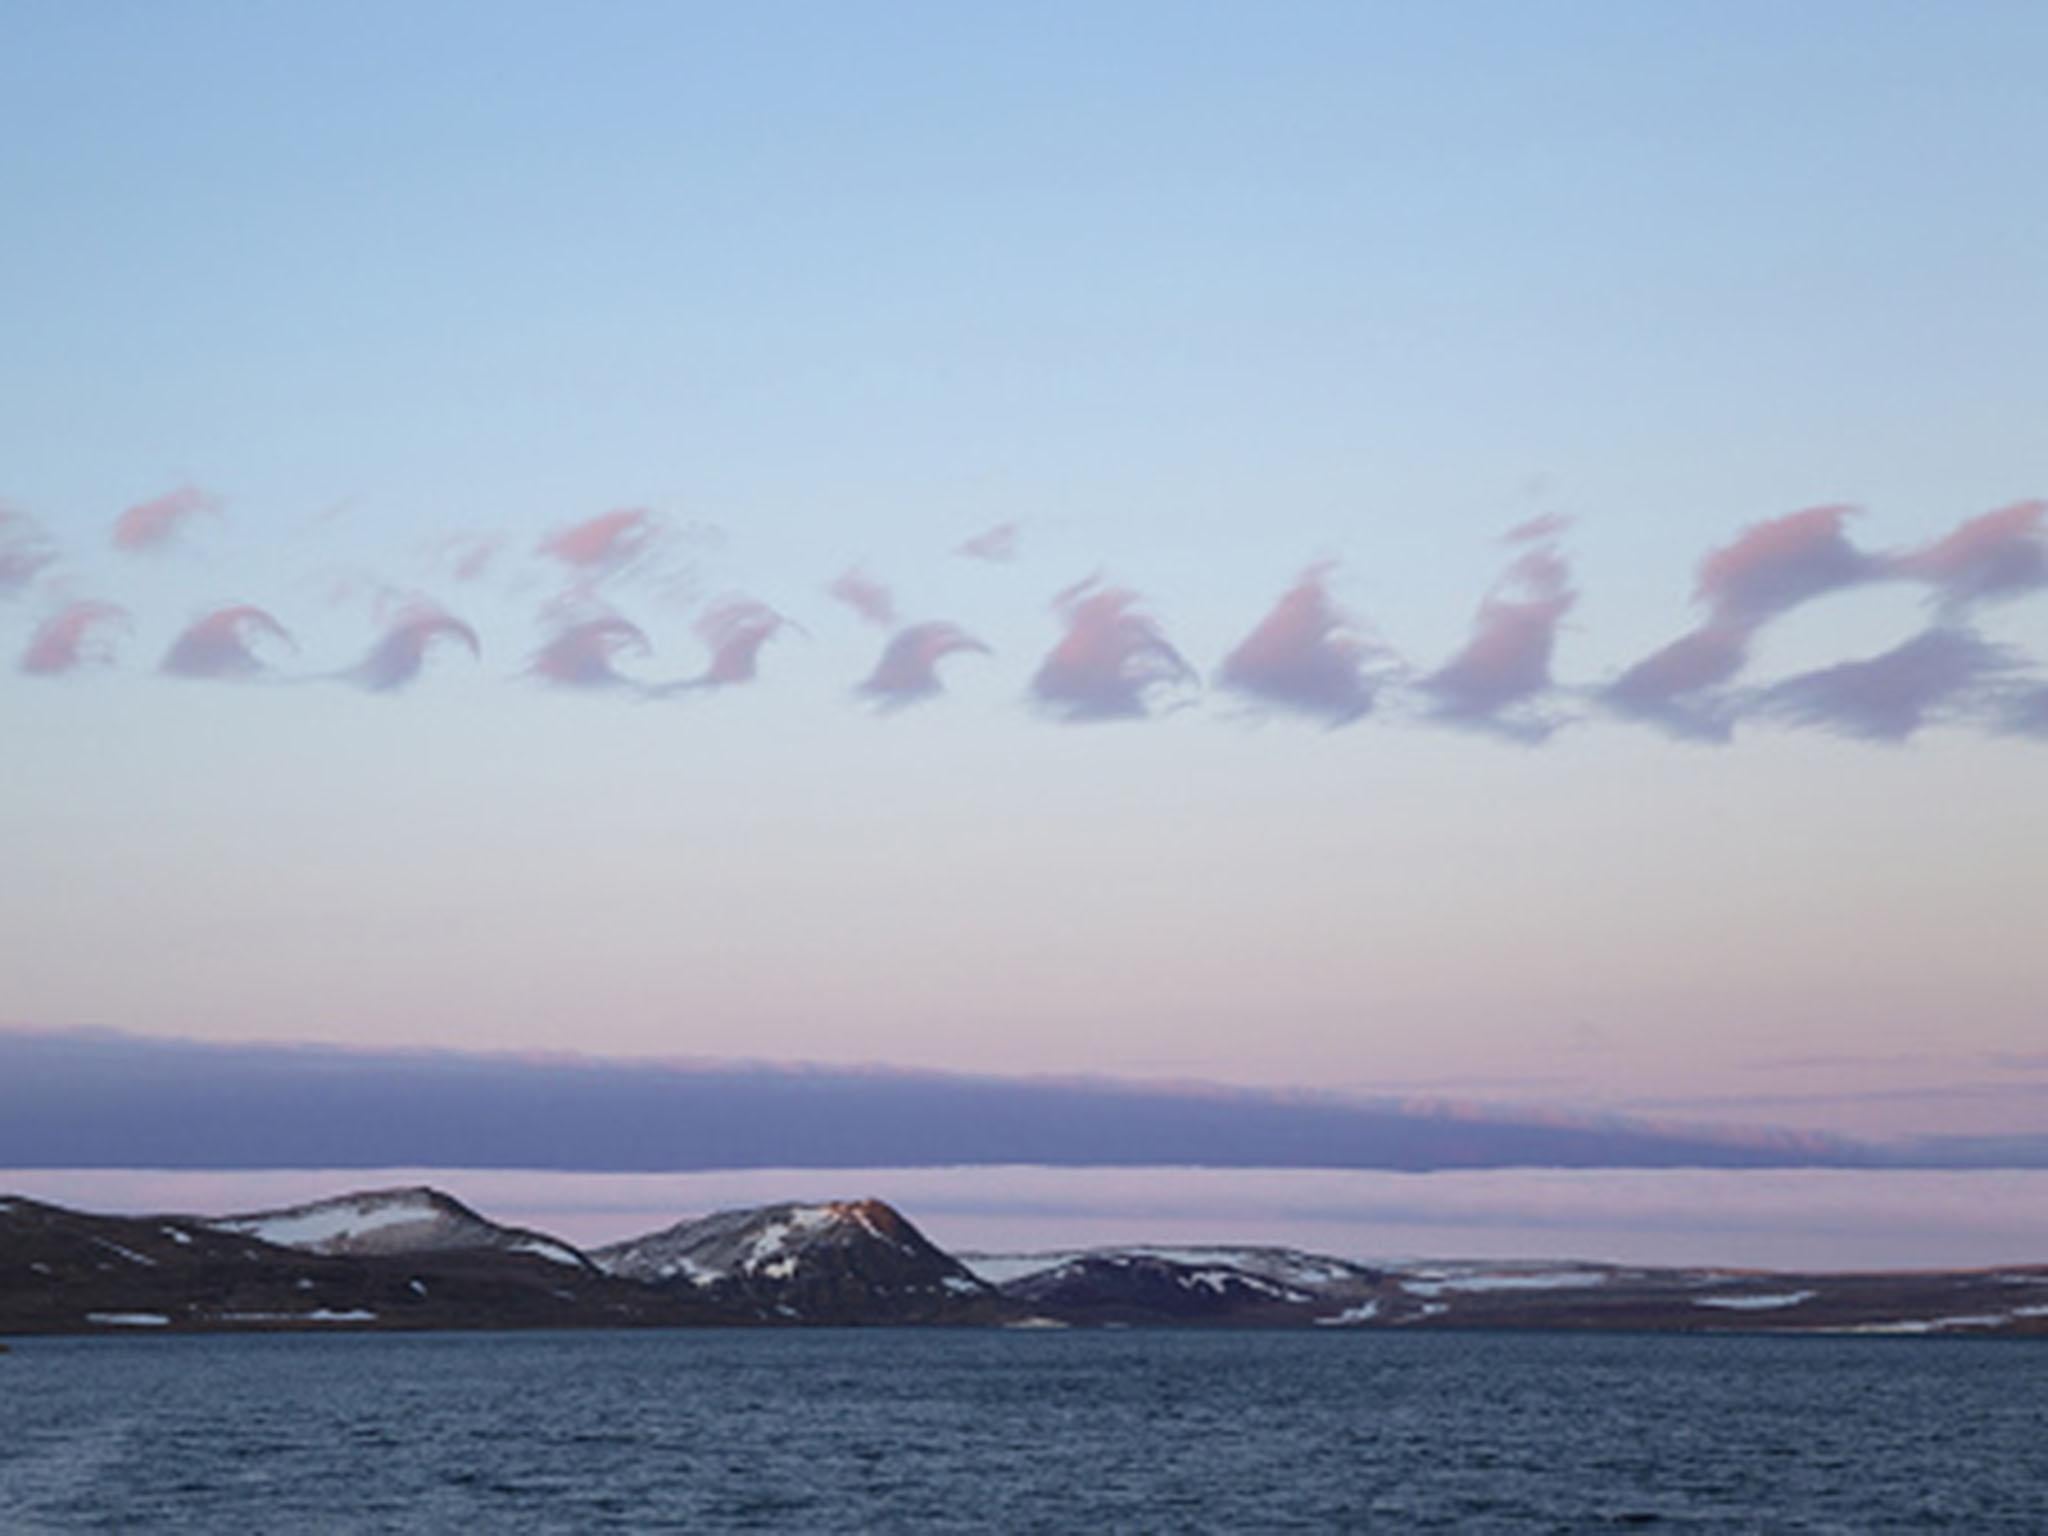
0;0;2048;1261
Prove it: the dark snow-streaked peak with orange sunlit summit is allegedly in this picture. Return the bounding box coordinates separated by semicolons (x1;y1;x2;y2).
592;1200;1006;1323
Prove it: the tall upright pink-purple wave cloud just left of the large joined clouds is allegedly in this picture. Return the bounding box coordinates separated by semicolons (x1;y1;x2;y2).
1421;545;1577;741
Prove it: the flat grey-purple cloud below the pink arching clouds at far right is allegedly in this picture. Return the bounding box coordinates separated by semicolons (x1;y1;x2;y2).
1761;627;2011;741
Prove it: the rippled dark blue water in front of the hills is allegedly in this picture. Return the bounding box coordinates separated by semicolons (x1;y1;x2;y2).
0;1331;2048;1534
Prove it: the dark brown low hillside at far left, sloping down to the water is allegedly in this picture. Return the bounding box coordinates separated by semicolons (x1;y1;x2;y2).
0;1196;735;1335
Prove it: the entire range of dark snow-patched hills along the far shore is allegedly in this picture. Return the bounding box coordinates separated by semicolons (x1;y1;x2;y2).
0;1188;2048;1335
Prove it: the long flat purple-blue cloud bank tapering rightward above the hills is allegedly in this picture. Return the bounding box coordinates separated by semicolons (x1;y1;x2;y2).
0;1030;1876;1171
